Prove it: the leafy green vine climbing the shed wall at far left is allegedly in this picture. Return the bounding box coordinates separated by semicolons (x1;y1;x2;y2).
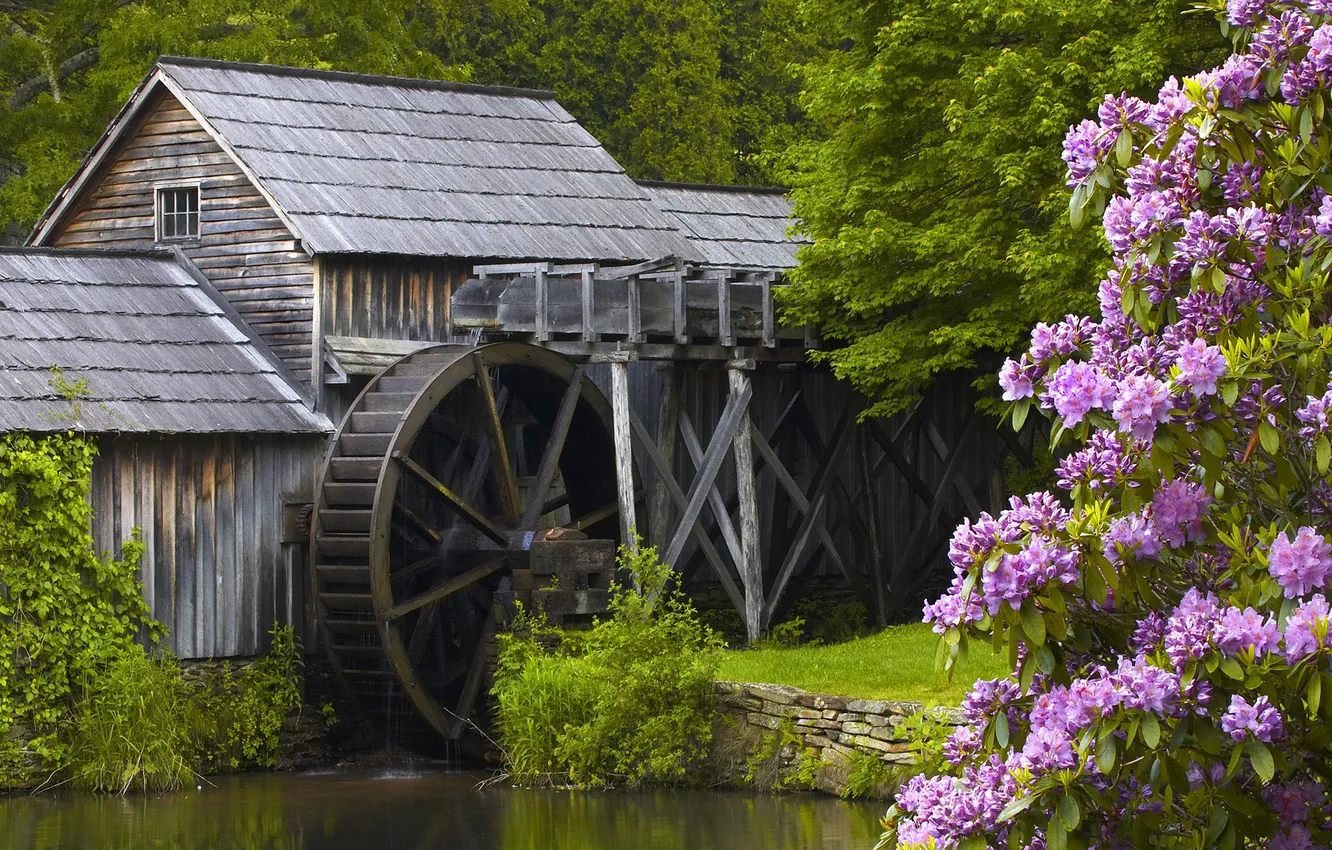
0;432;151;779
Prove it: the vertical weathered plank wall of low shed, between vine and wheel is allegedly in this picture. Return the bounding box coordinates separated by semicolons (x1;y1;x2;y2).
92;434;324;658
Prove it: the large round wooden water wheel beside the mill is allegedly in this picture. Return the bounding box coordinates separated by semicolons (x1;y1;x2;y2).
312;342;619;741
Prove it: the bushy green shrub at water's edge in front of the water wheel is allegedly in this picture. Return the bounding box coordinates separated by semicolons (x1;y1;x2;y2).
493;549;722;787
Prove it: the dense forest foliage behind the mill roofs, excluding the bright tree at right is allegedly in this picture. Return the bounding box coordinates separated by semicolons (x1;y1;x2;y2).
0;0;813;240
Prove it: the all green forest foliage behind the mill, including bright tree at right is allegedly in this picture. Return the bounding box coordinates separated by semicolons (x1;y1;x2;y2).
0;0;1225;414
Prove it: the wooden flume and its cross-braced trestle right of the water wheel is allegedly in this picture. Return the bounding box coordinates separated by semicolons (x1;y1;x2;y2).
452;258;1030;641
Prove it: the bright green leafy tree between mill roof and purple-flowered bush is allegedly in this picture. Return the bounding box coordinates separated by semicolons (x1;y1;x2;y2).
785;0;1225;414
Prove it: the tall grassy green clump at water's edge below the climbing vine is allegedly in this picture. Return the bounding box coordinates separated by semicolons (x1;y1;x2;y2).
68;646;194;794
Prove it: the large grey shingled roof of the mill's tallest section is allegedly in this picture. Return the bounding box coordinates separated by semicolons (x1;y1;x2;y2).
35;57;691;260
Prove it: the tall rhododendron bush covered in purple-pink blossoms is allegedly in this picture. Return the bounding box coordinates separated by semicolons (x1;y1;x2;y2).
884;0;1332;850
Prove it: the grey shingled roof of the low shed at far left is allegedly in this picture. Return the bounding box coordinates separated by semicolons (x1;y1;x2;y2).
0;248;332;433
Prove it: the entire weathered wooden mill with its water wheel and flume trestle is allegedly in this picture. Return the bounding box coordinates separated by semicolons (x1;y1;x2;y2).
15;59;1022;737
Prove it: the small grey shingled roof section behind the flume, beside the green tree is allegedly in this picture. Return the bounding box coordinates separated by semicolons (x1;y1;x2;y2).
638;180;802;270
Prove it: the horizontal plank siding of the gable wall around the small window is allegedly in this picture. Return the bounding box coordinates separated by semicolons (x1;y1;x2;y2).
52;95;314;381
